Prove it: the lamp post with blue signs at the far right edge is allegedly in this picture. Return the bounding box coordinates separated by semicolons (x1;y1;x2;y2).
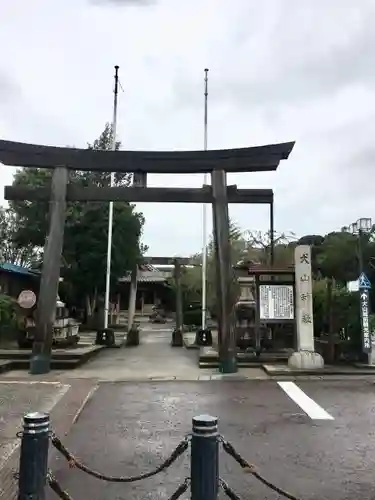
341;218;372;365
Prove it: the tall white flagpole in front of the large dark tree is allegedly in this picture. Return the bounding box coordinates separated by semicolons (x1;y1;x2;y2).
104;66;119;328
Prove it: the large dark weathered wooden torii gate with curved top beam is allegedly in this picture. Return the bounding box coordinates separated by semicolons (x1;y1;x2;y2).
0;141;294;374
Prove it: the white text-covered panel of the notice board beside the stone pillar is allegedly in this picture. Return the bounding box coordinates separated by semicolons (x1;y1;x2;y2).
259;285;294;321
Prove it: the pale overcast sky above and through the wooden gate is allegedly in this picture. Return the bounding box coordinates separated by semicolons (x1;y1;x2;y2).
0;0;375;256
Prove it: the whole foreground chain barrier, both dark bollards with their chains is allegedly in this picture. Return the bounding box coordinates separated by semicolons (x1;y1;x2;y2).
17;413;299;500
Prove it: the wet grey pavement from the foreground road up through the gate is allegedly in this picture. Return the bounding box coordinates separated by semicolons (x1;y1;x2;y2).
0;325;375;500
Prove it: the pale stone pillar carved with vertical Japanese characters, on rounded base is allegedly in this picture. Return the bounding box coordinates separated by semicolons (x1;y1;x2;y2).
288;245;324;369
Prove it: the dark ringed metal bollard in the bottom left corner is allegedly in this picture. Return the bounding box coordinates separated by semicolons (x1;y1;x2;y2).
18;412;50;500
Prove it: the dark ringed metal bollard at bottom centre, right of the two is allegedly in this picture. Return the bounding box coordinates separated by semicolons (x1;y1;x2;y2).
191;415;219;500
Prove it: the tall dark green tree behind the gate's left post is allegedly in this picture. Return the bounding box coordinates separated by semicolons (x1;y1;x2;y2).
11;124;146;314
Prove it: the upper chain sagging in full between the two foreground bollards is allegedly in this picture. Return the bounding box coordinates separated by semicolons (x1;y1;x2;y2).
51;434;190;483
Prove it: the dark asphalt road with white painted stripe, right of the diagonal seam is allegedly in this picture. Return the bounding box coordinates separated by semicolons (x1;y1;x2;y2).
49;380;375;500
